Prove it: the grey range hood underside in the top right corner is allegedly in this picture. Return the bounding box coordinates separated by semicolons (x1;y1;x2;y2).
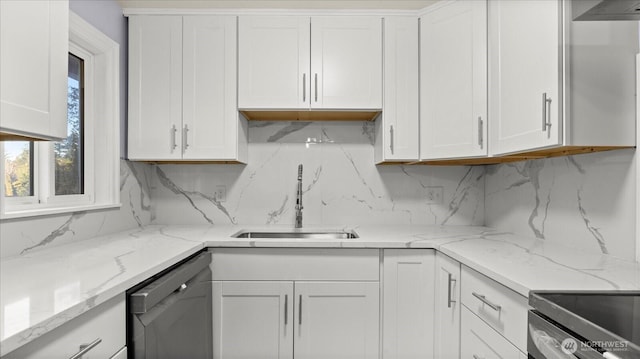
572;0;640;21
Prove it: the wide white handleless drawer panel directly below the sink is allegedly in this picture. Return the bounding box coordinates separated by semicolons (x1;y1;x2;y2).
211;248;380;281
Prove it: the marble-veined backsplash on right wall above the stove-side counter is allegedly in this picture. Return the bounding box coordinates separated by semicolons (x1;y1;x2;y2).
485;149;638;260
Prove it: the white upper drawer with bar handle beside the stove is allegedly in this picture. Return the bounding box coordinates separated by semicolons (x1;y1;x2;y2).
461;266;528;351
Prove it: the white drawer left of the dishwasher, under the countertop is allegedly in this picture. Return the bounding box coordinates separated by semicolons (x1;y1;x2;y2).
3;294;126;359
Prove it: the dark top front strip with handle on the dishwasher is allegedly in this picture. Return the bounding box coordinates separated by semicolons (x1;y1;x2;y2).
129;252;211;314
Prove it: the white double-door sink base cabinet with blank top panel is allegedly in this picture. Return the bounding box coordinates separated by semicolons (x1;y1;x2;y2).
212;248;380;359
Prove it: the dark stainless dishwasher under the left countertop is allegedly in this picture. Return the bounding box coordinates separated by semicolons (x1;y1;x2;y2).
127;252;213;359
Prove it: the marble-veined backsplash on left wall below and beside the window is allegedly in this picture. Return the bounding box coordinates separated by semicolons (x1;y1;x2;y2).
0;160;153;257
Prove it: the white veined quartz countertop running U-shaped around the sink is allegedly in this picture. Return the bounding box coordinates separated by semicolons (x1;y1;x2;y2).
0;226;640;355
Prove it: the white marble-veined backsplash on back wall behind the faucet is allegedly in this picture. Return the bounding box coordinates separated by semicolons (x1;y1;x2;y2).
151;122;485;226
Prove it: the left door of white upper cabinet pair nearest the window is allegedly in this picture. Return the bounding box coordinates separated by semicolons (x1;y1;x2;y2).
128;16;183;160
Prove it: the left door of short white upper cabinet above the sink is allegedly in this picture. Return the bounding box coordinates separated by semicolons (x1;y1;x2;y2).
238;16;311;109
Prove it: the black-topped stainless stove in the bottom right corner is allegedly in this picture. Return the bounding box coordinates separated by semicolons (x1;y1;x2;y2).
527;291;640;359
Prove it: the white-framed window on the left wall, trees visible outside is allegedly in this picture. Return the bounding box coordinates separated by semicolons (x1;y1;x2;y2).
1;12;120;218
